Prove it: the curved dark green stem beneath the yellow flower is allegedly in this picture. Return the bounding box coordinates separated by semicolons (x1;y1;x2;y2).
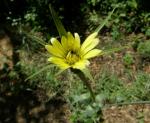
71;69;95;101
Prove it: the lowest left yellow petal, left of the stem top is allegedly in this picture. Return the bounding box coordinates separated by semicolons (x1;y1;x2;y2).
48;57;70;70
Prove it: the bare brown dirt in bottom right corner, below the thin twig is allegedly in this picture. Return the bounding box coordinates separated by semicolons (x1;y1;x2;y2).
103;104;150;123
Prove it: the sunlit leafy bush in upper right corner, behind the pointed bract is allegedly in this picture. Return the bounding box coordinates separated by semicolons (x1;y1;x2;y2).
86;0;150;34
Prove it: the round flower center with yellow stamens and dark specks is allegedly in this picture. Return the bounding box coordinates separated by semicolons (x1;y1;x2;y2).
66;51;80;65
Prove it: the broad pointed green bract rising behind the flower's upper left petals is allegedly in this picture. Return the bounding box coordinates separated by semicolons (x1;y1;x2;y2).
49;5;67;37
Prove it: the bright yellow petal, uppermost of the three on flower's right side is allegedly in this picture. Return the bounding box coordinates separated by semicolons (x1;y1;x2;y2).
81;32;98;51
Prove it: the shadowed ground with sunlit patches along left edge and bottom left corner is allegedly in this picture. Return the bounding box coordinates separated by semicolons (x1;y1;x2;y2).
0;30;69;123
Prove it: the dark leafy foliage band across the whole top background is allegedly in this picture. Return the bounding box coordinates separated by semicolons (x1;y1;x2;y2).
1;0;150;35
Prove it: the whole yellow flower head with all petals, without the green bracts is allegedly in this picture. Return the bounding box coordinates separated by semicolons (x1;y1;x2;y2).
45;32;101;70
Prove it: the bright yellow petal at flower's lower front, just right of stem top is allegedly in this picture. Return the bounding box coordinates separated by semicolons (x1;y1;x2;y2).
72;60;90;70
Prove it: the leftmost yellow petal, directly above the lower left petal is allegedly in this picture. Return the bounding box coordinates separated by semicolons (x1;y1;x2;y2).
45;45;63;57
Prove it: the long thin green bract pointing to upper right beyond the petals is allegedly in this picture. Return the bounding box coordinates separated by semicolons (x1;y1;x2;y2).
94;6;117;32
